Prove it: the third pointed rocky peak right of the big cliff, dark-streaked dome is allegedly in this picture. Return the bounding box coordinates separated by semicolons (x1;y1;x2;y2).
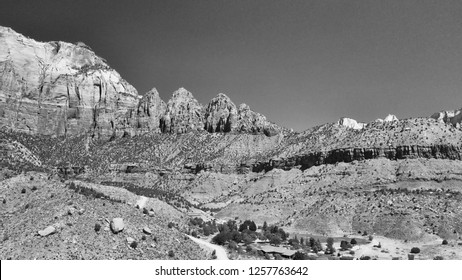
205;93;237;132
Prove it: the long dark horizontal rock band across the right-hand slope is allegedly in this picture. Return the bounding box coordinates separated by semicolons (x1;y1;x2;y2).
252;145;462;172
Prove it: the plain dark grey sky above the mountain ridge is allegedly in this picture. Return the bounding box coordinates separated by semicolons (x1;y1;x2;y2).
0;0;462;130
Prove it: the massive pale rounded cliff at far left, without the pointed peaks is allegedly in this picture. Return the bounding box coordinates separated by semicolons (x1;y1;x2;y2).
0;27;140;137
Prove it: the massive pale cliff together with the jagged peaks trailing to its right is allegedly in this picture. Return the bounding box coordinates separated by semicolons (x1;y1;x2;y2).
0;27;282;139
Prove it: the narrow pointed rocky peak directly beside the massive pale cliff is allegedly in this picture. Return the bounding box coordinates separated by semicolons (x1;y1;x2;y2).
138;88;167;132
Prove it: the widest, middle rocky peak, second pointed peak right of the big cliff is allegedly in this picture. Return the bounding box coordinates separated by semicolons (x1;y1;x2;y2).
160;88;204;133
